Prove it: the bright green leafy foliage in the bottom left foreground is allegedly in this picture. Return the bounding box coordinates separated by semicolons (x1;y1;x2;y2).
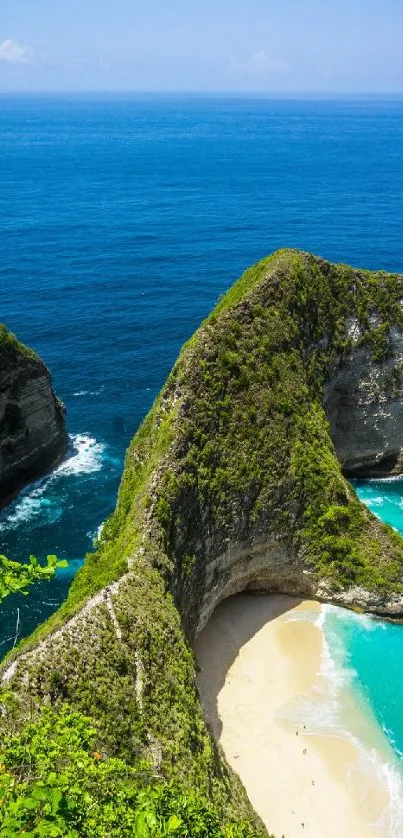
0;706;254;838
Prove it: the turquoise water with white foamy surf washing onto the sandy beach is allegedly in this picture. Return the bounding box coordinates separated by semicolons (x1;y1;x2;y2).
320;606;403;838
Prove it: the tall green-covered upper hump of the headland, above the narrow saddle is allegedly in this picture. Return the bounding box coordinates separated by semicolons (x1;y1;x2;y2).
92;246;403;611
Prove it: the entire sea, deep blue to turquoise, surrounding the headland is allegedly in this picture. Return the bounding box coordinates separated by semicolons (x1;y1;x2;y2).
0;96;403;836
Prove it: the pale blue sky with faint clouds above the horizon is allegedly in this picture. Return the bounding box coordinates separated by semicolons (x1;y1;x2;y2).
0;0;403;93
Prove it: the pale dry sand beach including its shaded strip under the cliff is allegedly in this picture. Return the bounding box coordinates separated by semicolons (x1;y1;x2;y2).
196;595;387;838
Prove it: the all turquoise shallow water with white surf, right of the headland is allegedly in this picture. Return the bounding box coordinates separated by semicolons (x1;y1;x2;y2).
312;478;403;838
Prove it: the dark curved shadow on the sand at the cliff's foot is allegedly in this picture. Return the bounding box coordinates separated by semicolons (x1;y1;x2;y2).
195;594;302;741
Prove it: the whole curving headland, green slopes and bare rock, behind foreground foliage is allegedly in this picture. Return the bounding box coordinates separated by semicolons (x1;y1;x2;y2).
3;251;403;834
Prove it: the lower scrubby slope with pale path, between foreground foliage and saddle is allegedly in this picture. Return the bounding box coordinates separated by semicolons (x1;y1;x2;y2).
3;566;265;836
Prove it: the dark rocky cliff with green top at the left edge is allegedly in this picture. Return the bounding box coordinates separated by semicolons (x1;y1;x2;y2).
0;326;67;507
